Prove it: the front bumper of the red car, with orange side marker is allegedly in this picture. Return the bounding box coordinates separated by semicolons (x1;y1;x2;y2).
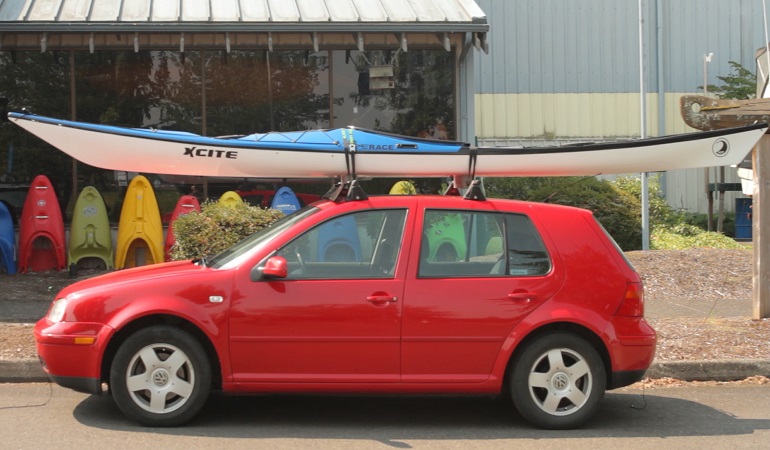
34;318;113;394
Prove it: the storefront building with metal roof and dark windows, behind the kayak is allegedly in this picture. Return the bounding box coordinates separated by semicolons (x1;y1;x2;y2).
0;0;489;219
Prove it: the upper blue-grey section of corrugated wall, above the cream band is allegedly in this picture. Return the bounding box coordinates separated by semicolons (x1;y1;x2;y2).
476;0;764;99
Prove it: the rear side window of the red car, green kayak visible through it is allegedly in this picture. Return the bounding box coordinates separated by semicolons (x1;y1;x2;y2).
418;210;551;278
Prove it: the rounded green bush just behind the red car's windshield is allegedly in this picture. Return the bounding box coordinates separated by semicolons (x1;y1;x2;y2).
171;202;284;260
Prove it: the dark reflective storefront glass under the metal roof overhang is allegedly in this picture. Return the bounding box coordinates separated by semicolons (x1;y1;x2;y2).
0;49;455;225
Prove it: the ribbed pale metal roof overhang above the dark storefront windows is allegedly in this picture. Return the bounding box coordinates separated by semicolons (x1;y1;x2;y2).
0;0;489;51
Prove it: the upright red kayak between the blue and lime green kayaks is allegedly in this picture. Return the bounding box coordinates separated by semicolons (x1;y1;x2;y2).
18;175;67;273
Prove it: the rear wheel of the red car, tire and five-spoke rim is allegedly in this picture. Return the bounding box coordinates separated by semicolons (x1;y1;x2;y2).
510;332;607;430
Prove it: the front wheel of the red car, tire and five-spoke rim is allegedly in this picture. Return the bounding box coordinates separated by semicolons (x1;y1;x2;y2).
110;325;211;427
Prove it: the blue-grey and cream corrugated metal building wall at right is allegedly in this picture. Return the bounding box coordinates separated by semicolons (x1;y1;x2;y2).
475;0;765;212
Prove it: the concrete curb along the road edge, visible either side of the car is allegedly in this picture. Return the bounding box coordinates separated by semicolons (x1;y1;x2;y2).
0;359;770;383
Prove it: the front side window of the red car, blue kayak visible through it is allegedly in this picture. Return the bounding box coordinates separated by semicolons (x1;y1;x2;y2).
277;210;406;279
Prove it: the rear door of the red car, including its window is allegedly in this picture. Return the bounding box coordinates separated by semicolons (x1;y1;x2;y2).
402;204;562;382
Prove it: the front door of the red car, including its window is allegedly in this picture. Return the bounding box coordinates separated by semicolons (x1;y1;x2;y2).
230;209;407;383
